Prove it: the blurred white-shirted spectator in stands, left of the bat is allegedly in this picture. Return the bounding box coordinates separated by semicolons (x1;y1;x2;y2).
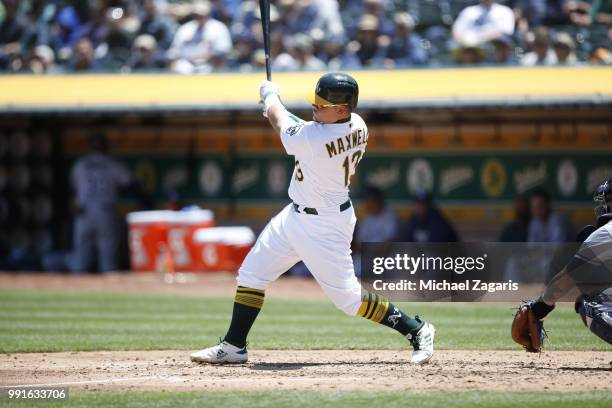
170;0;232;71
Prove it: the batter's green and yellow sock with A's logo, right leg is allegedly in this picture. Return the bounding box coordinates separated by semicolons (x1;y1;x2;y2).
357;292;423;336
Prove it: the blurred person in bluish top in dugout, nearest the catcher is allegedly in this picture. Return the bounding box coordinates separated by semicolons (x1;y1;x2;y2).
527;190;574;242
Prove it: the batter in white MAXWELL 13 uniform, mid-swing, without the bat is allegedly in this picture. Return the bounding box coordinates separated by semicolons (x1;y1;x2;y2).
191;73;435;364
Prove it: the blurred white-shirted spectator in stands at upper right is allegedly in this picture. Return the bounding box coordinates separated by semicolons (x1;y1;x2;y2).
453;0;514;47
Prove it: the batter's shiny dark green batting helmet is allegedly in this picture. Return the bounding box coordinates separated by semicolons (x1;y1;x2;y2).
308;72;359;109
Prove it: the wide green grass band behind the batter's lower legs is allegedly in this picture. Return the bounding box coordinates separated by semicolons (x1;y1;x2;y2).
0;290;610;353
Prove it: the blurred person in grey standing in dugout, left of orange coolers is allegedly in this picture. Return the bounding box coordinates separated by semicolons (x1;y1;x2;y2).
68;133;136;273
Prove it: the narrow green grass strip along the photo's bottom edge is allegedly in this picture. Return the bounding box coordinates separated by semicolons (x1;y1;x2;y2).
1;391;612;408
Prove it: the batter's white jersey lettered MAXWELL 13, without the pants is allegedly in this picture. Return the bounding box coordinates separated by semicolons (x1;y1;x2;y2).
281;113;368;208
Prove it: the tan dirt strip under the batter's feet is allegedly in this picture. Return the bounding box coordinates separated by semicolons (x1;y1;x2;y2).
0;350;612;391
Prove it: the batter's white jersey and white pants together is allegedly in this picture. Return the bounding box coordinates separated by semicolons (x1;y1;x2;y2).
237;114;368;316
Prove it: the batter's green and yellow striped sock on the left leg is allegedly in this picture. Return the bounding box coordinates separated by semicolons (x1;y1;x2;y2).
224;286;265;348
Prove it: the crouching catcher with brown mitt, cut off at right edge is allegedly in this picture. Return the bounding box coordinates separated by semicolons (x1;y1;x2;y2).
512;179;612;353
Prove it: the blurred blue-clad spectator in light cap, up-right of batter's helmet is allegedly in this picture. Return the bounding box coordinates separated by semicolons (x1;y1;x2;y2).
383;13;427;68
